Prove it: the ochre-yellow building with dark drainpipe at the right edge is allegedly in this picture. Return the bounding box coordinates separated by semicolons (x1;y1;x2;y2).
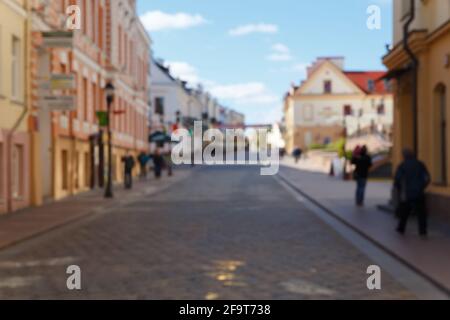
384;0;450;214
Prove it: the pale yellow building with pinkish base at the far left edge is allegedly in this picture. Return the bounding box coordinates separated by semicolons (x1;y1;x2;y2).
0;0;30;214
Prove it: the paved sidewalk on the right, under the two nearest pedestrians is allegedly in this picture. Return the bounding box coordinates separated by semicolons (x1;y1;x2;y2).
280;158;450;293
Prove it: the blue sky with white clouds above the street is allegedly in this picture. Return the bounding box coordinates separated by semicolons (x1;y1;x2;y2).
138;0;392;124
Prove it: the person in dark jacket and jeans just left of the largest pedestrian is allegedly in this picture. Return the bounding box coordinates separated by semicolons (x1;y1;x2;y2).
352;146;372;207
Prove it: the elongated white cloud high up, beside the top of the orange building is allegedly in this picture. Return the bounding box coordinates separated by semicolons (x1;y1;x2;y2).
140;11;207;32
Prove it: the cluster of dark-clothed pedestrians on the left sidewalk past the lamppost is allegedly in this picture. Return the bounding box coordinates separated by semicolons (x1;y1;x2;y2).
122;149;172;189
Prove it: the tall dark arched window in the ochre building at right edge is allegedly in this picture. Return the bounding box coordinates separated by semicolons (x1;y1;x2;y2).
433;84;447;185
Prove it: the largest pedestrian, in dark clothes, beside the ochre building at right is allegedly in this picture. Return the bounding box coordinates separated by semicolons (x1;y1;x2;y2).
394;149;431;236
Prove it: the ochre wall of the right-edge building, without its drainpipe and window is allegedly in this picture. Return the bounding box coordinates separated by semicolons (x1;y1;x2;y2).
384;0;450;215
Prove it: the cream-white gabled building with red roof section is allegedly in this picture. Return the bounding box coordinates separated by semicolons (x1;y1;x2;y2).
284;57;393;151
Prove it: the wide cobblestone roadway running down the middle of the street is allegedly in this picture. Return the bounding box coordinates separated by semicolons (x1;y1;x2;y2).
0;167;415;299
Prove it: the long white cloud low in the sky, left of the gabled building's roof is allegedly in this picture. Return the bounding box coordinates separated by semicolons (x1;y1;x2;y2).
210;82;279;104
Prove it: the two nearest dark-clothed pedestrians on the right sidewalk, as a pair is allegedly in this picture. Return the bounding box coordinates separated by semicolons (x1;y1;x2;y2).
351;146;431;236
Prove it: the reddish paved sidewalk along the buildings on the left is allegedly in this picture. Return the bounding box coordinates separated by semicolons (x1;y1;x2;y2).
0;169;191;250
